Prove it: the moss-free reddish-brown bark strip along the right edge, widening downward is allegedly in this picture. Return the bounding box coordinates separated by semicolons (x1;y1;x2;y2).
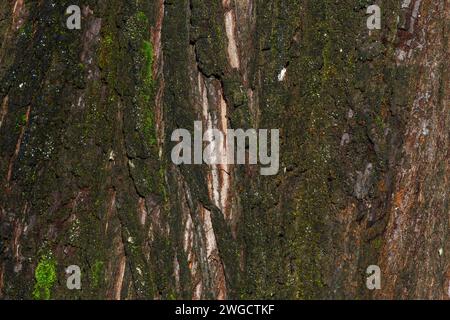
380;1;450;299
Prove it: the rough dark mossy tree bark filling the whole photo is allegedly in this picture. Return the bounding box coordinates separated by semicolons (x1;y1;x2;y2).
0;0;450;299
